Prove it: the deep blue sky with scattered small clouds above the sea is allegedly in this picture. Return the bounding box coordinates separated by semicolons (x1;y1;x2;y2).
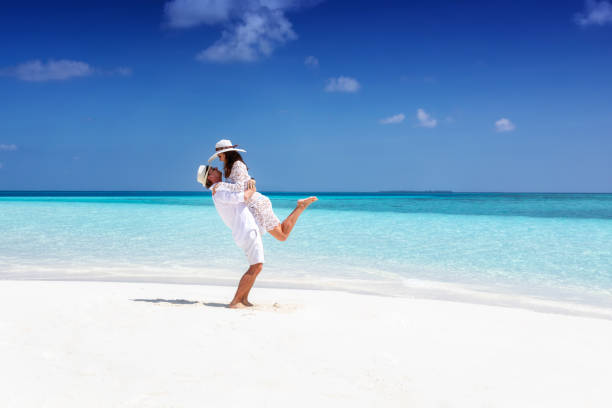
0;0;612;192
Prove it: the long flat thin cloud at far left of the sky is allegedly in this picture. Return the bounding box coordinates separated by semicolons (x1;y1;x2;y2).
0;59;132;82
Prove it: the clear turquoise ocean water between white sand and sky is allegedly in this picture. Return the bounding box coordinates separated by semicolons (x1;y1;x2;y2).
0;192;612;308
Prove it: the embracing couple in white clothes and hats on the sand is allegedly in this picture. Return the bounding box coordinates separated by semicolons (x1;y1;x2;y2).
197;140;317;308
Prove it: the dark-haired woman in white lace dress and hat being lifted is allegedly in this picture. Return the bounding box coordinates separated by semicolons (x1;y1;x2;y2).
209;140;318;241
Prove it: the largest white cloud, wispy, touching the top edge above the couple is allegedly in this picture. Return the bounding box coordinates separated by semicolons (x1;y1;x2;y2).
164;0;320;62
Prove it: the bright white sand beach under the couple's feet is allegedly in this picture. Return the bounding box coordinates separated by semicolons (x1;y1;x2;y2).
0;281;612;408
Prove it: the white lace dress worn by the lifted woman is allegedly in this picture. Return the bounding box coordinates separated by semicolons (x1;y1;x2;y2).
222;161;280;232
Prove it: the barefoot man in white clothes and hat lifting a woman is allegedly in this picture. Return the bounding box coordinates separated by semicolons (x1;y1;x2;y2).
198;166;264;308
